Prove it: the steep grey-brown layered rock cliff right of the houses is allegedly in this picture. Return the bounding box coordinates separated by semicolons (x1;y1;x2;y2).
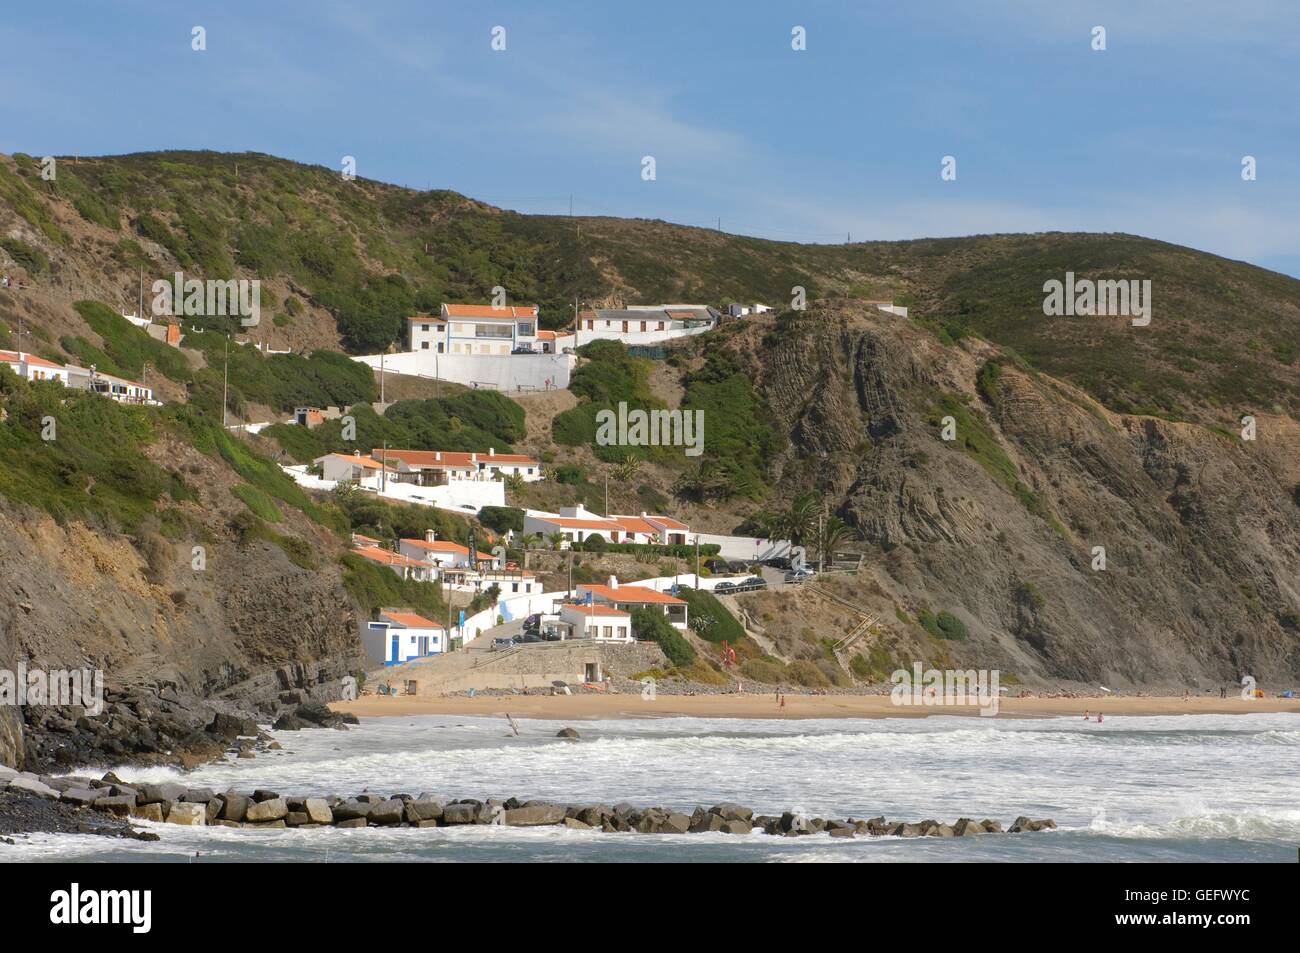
728;303;1300;689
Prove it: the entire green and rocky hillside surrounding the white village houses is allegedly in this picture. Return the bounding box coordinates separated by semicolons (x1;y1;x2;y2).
0;146;1300;759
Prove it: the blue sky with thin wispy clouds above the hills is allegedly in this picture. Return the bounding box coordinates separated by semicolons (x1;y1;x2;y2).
0;0;1300;276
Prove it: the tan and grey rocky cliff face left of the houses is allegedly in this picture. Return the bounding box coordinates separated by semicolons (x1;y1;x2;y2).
0;486;364;764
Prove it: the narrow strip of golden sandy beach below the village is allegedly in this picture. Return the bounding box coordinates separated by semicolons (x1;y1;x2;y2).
330;694;1300;720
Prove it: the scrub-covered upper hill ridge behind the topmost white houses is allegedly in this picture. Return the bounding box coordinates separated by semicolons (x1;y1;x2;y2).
0;152;1300;425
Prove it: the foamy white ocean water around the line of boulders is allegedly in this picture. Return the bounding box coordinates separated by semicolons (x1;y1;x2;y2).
0;714;1300;863
